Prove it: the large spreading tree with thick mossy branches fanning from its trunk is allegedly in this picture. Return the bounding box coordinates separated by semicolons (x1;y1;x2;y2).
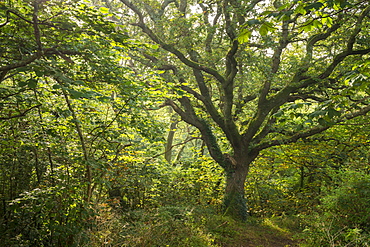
112;0;370;219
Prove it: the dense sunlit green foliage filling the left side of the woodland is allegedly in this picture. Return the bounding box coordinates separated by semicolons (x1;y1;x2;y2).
0;1;157;246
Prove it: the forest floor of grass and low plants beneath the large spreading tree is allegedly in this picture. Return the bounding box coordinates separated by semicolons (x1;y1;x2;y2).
90;207;306;247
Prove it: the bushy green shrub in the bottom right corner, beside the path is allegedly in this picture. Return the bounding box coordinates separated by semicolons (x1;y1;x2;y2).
303;174;370;247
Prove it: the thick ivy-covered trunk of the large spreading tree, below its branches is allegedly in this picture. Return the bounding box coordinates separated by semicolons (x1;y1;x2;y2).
223;164;249;221
